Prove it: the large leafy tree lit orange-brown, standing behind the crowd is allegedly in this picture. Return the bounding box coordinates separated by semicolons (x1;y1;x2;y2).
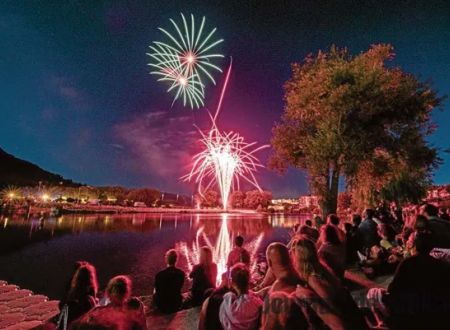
270;45;441;215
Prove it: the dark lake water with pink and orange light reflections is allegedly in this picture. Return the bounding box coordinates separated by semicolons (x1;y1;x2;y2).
0;214;303;299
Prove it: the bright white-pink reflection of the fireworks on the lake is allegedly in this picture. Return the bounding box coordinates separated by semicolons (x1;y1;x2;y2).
177;214;264;285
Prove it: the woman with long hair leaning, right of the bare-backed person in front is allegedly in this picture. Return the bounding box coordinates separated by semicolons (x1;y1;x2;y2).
292;238;367;329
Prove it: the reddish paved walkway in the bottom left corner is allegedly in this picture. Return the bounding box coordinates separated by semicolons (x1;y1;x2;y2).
0;281;59;330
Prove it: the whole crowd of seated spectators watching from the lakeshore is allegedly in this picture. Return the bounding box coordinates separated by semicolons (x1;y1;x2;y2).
46;204;450;330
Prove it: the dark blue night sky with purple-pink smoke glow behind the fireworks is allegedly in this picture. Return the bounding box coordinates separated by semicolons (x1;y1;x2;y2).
0;0;450;197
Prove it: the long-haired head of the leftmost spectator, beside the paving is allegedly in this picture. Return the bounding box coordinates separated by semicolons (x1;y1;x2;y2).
68;261;98;300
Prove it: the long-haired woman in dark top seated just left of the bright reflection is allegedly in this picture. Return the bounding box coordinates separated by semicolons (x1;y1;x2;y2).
185;246;217;307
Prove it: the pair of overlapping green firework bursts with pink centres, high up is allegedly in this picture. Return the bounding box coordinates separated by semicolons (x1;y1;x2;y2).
148;14;224;108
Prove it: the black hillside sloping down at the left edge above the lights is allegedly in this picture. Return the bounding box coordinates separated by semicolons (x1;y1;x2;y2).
0;148;78;187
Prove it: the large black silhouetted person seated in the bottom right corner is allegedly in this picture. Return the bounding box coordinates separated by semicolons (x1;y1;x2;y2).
367;233;450;329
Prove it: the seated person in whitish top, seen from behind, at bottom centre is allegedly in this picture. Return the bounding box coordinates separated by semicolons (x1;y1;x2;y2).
219;263;263;330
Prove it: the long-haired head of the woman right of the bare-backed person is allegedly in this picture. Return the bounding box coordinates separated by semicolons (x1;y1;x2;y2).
292;238;320;279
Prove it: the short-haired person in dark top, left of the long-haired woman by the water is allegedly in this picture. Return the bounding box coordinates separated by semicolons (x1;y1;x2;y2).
153;250;185;314
